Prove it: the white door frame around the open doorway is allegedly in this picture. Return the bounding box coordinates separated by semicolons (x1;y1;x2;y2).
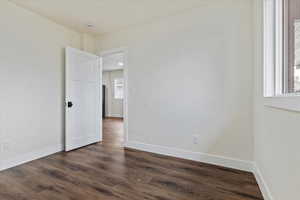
97;47;128;147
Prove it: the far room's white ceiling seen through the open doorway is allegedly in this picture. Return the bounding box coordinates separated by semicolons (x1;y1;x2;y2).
103;53;124;71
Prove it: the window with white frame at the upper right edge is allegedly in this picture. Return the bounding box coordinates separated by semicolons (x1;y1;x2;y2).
264;0;300;97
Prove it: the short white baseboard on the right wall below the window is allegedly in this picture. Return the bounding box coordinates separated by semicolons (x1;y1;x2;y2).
253;163;274;200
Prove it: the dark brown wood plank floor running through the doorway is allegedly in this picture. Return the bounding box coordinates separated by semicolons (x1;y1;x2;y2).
0;119;263;200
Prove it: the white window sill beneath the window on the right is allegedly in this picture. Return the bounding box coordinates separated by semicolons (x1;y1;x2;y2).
264;94;300;112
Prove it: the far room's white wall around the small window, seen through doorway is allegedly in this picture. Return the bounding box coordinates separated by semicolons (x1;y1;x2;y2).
103;70;124;117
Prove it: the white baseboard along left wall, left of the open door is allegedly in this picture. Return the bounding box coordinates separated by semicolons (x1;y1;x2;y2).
0;145;63;171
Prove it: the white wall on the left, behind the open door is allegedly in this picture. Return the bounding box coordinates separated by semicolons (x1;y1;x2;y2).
0;0;92;169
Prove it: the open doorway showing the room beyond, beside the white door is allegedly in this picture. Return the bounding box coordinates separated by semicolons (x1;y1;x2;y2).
100;49;127;147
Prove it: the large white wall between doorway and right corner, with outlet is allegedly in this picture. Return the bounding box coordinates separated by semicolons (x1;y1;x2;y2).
98;0;253;160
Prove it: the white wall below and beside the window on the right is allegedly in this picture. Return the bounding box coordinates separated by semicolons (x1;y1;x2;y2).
254;0;300;200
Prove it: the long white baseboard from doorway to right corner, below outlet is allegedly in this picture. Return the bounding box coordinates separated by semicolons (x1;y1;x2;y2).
125;142;253;172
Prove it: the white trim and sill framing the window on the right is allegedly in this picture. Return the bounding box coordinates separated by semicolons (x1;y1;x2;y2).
263;0;300;112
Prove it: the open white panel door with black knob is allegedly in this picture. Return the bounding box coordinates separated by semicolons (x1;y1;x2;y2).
65;47;102;151
